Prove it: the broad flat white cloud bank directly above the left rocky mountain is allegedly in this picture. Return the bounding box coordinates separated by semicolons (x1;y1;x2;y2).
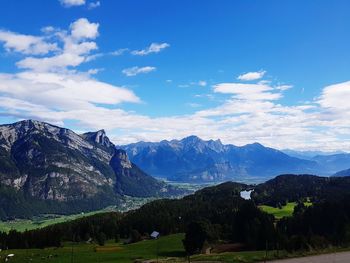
0;72;140;127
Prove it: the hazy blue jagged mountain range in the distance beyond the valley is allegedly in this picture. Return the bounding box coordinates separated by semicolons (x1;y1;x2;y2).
118;136;319;182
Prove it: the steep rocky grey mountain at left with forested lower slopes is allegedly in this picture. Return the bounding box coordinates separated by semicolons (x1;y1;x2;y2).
0;120;180;220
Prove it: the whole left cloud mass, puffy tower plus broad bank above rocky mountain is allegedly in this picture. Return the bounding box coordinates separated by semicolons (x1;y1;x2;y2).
0;18;141;134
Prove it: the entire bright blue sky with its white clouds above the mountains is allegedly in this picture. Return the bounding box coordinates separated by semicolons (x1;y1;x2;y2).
0;0;350;151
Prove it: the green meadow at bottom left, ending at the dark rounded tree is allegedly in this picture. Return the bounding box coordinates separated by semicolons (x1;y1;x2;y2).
0;234;185;263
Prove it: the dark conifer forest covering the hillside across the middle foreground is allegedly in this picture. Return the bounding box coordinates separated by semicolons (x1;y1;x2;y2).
0;175;350;254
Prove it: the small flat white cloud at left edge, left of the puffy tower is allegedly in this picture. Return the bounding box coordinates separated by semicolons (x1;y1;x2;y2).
0;30;58;55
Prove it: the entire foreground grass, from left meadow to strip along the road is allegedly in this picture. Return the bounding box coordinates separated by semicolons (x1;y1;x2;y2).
0;234;344;263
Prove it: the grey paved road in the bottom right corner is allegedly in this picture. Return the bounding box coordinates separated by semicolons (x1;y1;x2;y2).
268;252;350;263
